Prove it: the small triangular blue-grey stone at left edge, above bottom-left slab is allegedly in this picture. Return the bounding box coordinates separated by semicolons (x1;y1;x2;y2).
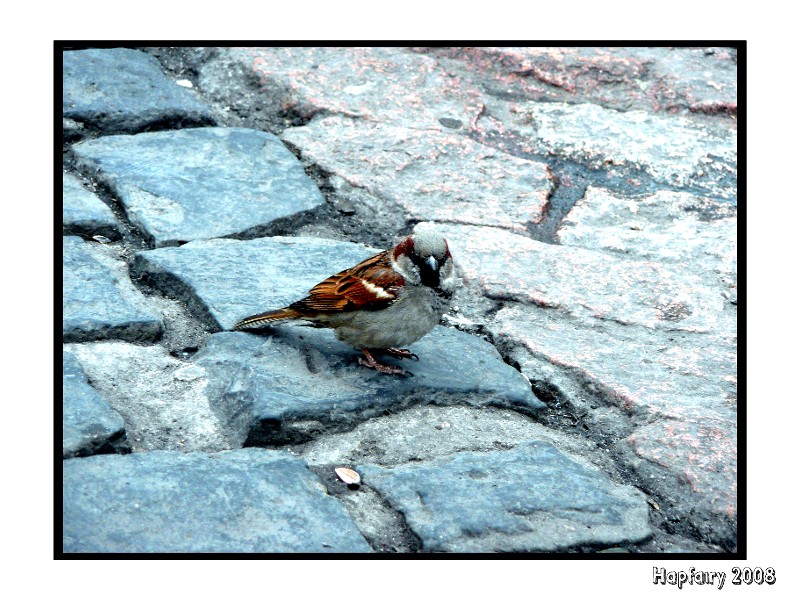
61;352;129;458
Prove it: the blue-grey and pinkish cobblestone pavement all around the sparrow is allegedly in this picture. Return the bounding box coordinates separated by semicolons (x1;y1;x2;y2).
63;47;738;553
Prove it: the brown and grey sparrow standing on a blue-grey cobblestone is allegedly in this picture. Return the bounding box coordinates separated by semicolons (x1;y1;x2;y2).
233;232;456;375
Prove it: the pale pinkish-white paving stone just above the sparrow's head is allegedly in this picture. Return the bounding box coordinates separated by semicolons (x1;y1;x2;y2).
283;117;553;231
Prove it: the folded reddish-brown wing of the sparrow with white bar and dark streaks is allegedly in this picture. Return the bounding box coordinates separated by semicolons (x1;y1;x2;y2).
289;251;405;313
